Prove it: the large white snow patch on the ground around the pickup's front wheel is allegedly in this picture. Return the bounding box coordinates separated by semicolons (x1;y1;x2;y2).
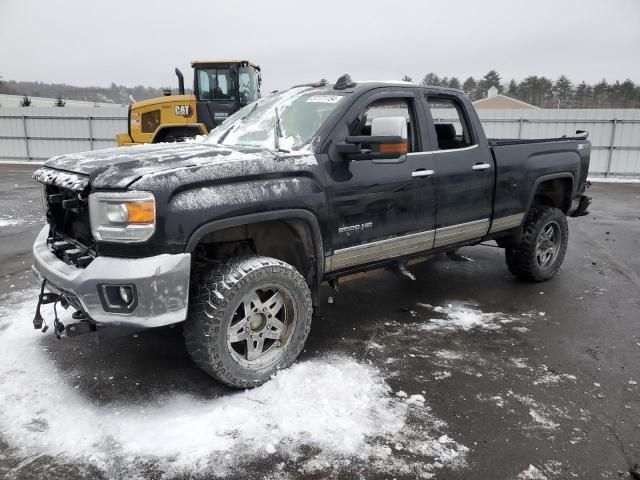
0;291;467;478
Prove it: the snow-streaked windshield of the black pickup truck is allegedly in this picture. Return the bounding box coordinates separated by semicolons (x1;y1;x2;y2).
204;87;343;151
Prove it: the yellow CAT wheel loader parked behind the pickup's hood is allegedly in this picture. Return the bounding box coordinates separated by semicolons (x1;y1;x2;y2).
116;60;262;146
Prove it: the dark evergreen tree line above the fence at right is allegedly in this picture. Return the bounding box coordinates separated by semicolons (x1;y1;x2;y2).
403;70;640;108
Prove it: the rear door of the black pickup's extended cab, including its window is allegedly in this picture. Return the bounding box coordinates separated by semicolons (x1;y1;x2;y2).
423;92;495;248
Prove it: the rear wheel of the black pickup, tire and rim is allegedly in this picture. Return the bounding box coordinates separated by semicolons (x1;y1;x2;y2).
505;206;569;282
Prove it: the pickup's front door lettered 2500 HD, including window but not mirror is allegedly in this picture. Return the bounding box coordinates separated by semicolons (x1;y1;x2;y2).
326;89;436;271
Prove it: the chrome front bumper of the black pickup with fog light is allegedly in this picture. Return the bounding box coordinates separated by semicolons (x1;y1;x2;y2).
33;226;191;329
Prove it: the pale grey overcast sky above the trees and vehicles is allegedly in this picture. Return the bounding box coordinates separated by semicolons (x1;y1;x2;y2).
0;0;640;91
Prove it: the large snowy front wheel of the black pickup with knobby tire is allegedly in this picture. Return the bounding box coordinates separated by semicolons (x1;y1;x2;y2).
184;256;313;388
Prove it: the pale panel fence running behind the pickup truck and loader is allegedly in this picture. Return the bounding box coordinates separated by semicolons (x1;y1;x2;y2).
0;107;640;177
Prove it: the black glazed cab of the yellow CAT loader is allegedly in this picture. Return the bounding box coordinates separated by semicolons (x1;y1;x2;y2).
191;60;261;130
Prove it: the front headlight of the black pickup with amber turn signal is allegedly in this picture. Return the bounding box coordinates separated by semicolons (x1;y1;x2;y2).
89;192;156;242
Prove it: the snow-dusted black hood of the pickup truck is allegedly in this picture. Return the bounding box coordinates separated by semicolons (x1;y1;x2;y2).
44;143;276;189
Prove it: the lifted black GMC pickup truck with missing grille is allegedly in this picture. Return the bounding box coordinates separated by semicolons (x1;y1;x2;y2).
33;76;591;387
